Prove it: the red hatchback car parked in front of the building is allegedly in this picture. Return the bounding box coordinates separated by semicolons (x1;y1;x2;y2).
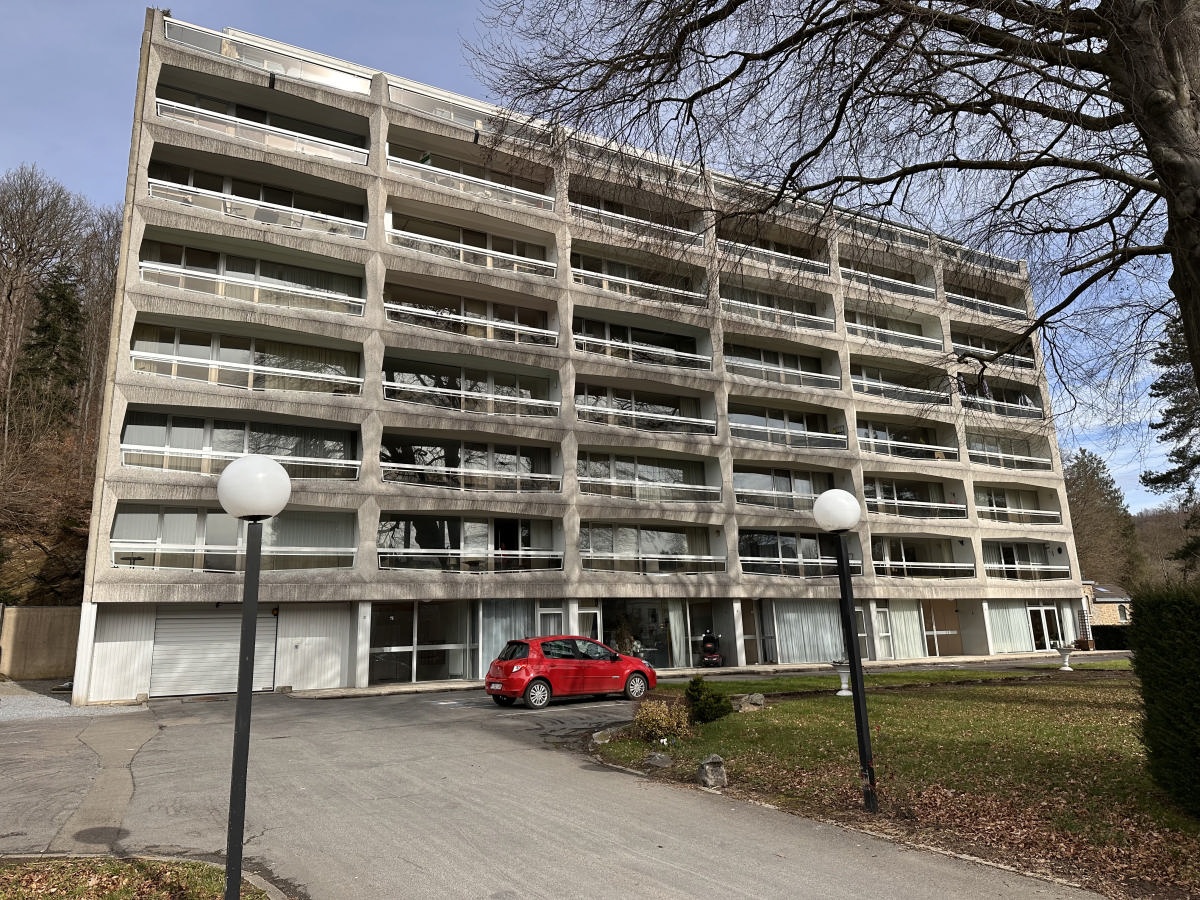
486;635;658;709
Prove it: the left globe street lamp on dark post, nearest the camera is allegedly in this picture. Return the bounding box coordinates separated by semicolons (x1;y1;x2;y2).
217;455;292;900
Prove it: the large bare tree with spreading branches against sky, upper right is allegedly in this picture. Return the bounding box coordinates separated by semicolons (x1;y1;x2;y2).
473;0;1200;401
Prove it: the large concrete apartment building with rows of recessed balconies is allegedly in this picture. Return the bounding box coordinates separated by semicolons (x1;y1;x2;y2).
73;11;1081;703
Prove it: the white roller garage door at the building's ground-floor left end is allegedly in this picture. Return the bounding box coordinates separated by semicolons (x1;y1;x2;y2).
150;606;276;697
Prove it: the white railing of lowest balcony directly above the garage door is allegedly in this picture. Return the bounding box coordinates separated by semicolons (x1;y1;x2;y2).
109;541;358;572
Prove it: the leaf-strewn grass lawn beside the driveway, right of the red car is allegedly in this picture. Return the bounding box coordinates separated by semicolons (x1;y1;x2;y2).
609;662;1200;898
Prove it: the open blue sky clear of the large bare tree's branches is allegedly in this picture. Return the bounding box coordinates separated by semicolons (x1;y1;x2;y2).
0;0;1162;511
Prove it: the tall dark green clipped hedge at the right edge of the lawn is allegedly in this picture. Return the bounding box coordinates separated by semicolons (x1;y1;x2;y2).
1129;584;1200;815
